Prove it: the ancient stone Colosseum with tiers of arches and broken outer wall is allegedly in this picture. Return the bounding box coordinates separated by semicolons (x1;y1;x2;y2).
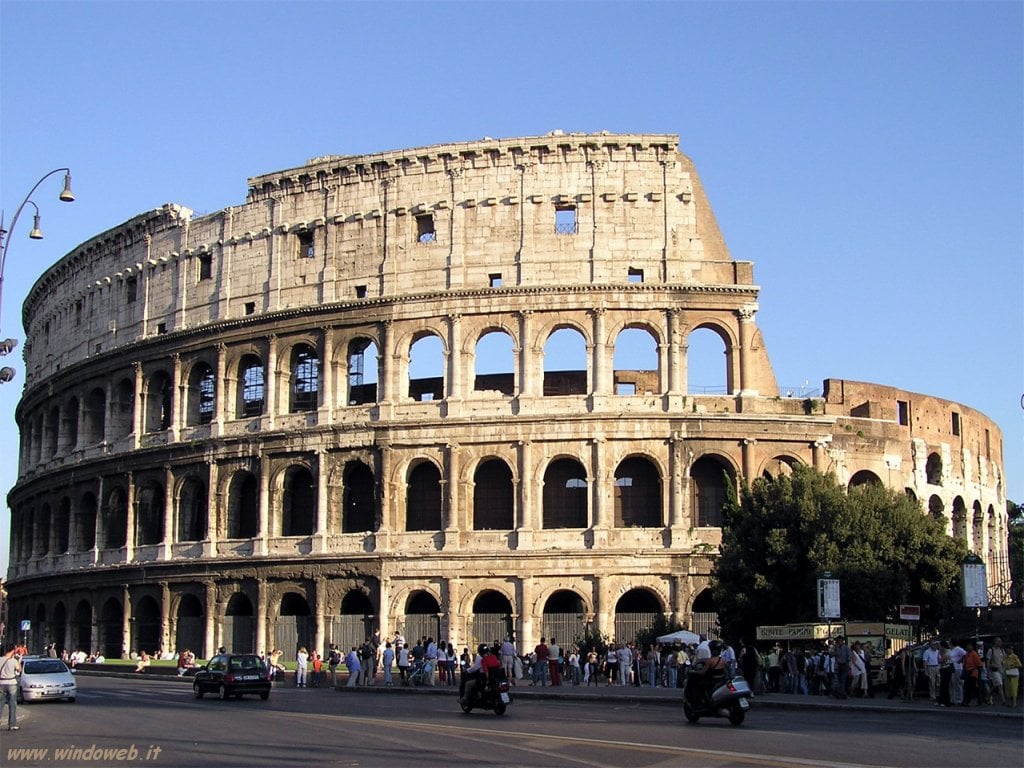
7;131;1008;657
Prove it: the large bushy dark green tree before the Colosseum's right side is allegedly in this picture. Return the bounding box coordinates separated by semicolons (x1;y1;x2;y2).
712;466;967;638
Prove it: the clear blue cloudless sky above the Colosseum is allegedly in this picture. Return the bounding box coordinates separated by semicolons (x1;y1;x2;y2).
0;0;1024;570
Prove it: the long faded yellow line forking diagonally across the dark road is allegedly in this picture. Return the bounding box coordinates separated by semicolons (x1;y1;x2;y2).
275;712;885;768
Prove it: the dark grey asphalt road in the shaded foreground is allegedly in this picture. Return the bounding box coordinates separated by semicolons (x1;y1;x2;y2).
0;676;1022;768
